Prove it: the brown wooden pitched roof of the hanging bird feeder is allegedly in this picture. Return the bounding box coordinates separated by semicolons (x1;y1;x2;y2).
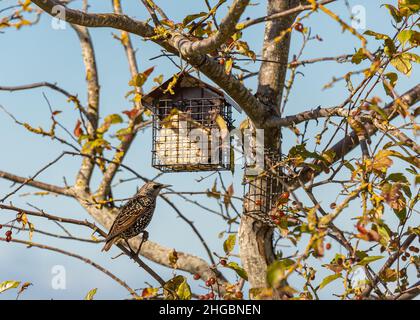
142;73;242;113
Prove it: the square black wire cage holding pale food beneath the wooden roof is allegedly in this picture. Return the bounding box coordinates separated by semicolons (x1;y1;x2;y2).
152;98;234;172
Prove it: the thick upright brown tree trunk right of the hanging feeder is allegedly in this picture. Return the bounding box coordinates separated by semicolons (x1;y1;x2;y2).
238;0;298;298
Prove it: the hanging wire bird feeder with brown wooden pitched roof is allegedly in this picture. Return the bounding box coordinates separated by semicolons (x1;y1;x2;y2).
143;73;233;172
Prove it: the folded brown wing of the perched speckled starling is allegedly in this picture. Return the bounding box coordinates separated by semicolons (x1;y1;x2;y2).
106;197;151;241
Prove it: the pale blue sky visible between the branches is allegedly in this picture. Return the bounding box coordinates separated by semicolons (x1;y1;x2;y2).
0;0;420;299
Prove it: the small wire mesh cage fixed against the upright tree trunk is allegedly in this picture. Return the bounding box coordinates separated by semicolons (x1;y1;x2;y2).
244;152;283;216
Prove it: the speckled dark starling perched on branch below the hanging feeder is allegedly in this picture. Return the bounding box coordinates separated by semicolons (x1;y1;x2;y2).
102;181;168;251
